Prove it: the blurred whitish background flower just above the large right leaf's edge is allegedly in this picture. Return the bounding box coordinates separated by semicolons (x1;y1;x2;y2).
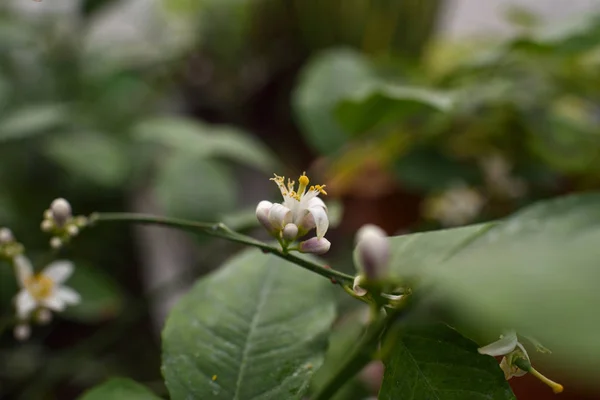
424;184;485;227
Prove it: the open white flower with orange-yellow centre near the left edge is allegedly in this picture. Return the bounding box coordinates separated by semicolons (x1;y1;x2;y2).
14;255;81;320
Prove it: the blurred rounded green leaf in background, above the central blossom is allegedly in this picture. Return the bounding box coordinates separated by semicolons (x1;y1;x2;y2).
292;49;375;154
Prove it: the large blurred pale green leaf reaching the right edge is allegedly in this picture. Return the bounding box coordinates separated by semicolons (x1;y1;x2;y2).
391;193;600;378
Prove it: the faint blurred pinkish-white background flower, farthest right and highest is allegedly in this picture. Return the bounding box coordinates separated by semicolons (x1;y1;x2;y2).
481;154;527;199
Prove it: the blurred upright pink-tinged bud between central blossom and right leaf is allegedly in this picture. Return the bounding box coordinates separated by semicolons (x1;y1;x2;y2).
355;225;390;280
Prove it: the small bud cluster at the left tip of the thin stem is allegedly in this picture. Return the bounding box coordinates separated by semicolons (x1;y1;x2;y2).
41;198;88;249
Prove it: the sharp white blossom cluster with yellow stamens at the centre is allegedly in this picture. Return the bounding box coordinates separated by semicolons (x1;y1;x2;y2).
256;174;331;254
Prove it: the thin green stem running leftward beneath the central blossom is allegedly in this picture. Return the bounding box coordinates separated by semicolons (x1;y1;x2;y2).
90;213;354;285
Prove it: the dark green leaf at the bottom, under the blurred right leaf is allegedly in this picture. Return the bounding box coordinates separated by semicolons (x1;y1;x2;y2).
379;325;516;400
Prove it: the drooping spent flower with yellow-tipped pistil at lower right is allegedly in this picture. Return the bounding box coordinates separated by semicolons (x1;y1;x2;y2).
478;330;563;393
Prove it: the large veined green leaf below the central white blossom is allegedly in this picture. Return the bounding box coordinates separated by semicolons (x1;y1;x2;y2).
163;249;335;400
